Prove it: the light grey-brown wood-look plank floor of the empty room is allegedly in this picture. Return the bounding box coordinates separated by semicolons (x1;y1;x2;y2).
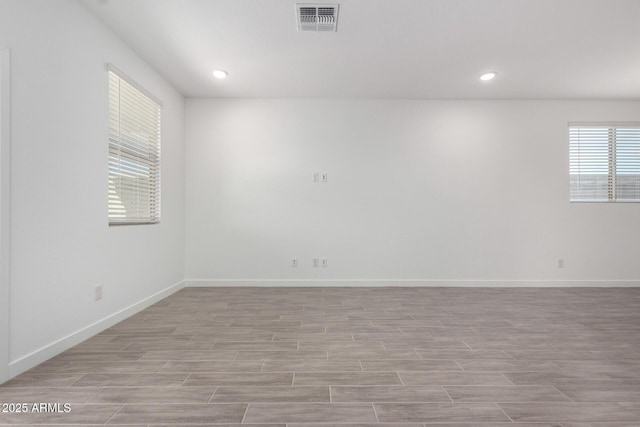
0;288;640;427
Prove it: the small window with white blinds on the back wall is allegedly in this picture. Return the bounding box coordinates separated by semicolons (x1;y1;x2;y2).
569;124;640;202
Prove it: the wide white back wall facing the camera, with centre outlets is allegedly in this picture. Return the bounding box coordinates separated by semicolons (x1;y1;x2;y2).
186;99;640;286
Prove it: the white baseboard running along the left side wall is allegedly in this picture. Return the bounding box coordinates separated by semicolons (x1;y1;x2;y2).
9;281;185;378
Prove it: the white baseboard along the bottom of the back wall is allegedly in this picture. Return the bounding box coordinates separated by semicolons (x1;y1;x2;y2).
185;279;640;288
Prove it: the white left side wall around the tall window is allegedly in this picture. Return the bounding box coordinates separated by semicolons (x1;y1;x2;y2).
0;0;184;375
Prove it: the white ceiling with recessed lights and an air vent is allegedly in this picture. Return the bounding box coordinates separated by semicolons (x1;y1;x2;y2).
81;0;640;100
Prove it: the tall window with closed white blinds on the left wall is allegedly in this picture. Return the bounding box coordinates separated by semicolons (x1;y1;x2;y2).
107;65;162;225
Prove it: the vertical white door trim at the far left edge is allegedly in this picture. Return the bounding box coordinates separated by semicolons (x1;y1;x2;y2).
0;49;11;384
